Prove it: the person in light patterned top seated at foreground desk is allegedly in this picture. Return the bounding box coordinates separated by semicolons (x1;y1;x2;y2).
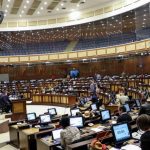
60;117;81;149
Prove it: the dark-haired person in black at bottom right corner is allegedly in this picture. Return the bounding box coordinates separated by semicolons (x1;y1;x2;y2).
136;114;150;150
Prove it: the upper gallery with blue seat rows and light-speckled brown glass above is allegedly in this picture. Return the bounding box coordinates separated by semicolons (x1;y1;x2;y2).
0;3;150;56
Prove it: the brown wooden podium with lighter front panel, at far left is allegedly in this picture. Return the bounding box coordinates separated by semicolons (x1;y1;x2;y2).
11;99;26;121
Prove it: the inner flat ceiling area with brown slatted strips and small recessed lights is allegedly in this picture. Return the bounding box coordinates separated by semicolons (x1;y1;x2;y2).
0;0;117;20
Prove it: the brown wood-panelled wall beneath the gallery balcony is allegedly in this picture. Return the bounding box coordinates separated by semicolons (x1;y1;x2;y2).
0;56;150;80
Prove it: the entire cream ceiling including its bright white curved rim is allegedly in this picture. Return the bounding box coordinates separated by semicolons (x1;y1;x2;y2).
0;0;150;31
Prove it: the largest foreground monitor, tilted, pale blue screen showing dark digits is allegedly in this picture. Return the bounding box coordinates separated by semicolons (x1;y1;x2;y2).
111;123;132;145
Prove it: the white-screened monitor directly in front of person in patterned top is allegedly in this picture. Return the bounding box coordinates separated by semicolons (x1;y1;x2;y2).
69;116;84;128
